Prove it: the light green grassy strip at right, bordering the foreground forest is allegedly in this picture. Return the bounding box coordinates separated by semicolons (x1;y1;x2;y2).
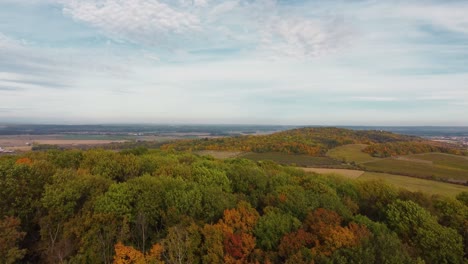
358;172;468;197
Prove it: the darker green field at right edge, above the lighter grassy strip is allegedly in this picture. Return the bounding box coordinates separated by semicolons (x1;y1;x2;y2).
361;154;468;182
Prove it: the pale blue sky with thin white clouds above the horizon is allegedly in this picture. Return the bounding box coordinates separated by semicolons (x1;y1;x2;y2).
0;0;468;126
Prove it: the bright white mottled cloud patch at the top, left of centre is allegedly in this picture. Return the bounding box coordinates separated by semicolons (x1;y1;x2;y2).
63;0;204;45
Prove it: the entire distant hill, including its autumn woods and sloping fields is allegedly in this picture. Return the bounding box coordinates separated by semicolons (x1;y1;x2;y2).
175;128;468;185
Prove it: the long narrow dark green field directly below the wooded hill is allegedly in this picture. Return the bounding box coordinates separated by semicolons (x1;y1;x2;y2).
241;152;342;168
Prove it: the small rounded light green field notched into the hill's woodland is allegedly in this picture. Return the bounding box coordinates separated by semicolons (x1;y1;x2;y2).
327;144;378;164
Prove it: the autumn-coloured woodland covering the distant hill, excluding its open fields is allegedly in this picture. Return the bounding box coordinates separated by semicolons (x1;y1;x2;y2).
162;128;467;157
